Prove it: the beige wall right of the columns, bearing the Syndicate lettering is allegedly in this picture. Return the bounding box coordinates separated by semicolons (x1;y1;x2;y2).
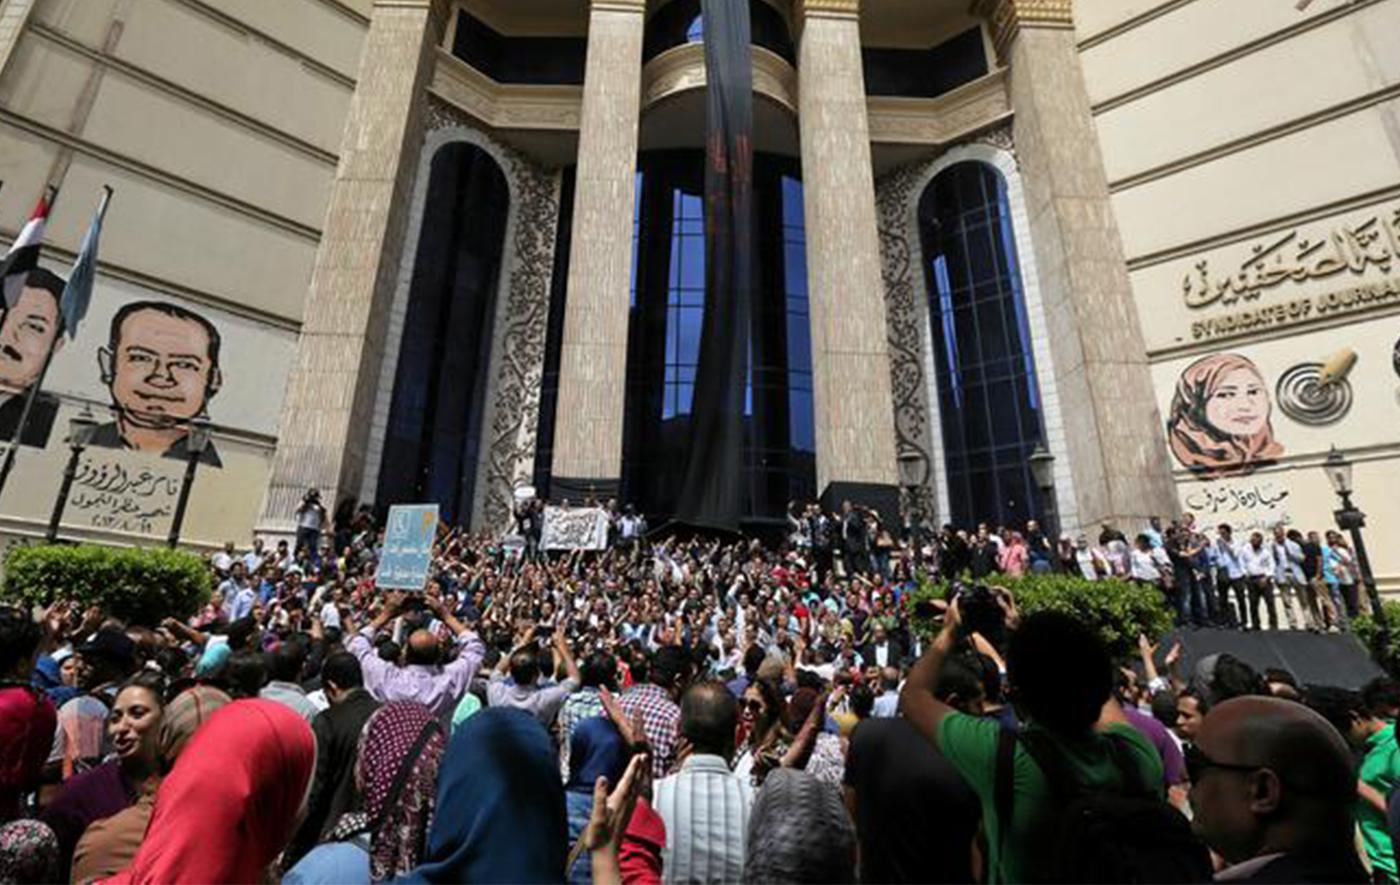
1075;0;1400;590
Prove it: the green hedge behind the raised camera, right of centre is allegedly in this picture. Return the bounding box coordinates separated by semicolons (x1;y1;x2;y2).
913;574;1181;658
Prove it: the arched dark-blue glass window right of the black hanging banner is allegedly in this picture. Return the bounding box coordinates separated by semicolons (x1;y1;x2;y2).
918;162;1043;527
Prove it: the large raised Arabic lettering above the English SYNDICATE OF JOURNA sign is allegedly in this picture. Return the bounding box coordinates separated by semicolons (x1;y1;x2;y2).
1182;207;1400;309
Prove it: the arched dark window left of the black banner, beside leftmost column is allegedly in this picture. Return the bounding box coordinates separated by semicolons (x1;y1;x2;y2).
378;141;510;524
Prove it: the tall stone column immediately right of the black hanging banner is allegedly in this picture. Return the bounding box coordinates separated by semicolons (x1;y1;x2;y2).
795;0;899;520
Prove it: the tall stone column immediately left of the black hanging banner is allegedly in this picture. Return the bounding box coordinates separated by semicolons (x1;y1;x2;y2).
550;0;647;501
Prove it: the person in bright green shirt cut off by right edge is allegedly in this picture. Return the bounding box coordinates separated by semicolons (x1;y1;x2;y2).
1308;688;1400;882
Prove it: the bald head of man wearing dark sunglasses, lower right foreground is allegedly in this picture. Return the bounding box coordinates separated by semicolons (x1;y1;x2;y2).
1189;696;1355;863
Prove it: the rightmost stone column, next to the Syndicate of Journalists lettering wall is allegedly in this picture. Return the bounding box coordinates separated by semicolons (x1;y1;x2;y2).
974;0;1179;534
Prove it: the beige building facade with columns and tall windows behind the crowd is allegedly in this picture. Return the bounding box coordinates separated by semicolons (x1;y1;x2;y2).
0;0;1400;584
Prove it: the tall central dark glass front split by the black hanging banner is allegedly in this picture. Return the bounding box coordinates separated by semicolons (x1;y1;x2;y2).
622;150;816;522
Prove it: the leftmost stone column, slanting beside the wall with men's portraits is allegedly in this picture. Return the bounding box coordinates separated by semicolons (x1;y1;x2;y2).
259;0;449;532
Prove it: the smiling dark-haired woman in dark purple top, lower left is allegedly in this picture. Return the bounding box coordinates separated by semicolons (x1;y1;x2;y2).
41;671;165;877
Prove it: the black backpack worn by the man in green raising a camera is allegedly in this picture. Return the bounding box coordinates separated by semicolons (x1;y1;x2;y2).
994;730;1211;882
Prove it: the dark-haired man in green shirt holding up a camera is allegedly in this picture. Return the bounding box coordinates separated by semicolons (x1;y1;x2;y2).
900;601;1162;882
